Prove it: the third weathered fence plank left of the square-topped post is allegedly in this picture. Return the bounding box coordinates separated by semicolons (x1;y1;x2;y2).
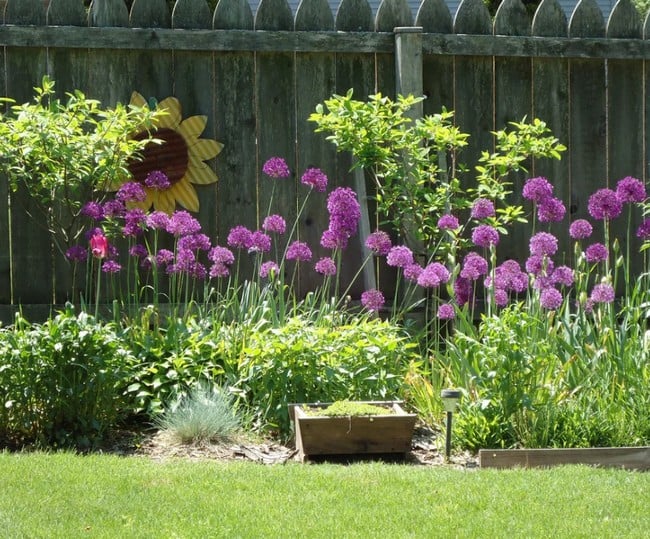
295;0;334;294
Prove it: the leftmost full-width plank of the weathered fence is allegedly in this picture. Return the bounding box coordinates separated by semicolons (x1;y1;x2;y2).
5;0;54;305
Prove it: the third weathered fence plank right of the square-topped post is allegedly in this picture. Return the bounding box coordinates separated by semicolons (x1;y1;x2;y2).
494;0;532;260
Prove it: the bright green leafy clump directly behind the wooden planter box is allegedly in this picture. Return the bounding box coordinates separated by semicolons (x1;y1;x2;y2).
236;317;415;434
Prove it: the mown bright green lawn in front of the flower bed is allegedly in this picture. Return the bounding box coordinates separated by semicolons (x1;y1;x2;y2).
0;453;650;539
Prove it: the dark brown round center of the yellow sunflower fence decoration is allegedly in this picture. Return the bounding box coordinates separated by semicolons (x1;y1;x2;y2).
129;127;189;185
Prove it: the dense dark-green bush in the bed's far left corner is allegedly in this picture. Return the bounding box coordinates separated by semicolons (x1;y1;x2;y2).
0;307;132;448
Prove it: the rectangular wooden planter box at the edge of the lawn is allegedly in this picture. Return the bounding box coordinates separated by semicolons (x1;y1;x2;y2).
289;401;417;462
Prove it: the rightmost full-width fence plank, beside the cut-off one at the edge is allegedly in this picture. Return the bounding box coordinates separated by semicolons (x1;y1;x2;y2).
606;0;645;286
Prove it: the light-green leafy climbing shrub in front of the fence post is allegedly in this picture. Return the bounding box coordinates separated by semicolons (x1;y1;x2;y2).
309;90;566;258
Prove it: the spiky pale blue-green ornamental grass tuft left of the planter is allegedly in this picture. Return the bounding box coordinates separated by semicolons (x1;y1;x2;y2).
156;383;241;443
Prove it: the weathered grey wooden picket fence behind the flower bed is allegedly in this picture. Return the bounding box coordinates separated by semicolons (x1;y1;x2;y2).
0;0;650;316
